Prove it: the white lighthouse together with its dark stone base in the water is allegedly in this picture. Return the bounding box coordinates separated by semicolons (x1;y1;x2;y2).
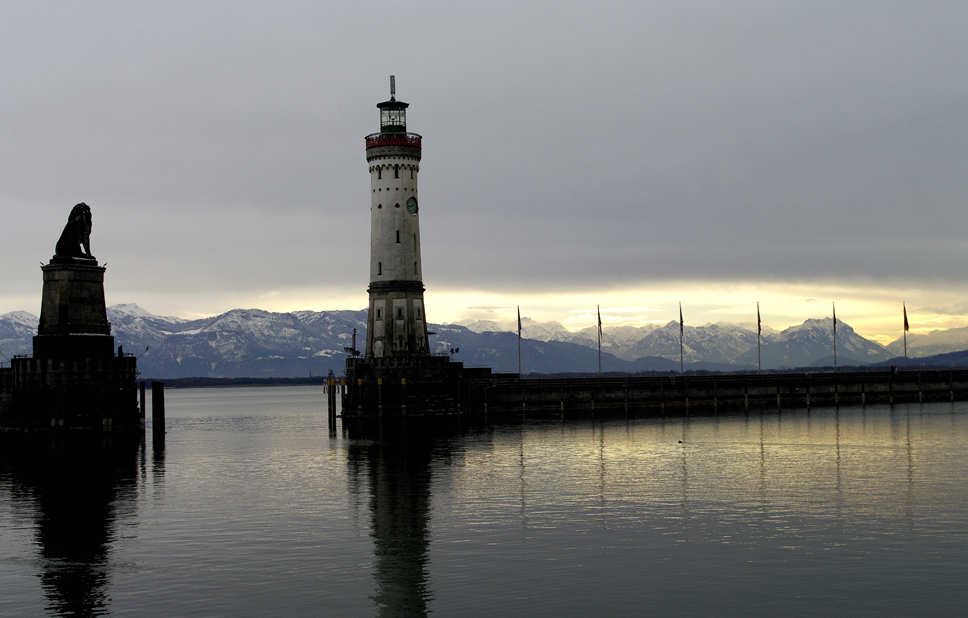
342;75;491;417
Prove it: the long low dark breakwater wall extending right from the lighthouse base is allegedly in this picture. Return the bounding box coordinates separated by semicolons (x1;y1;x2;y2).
465;369;968;416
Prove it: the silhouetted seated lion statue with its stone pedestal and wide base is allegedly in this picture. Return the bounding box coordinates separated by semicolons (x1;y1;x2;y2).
0;204;144;434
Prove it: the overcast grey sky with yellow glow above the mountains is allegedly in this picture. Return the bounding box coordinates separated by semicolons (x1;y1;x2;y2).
0;0;968;344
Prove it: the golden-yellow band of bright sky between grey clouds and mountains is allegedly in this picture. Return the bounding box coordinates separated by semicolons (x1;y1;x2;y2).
107;282;968;345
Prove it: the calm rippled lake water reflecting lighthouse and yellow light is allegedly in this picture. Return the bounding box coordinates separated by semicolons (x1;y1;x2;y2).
0;387;968;617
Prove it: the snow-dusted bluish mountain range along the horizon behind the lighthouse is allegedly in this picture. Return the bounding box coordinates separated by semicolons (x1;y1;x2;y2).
0;304;968;379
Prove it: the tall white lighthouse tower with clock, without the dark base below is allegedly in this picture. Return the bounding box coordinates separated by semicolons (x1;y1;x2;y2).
366;76;430;364
